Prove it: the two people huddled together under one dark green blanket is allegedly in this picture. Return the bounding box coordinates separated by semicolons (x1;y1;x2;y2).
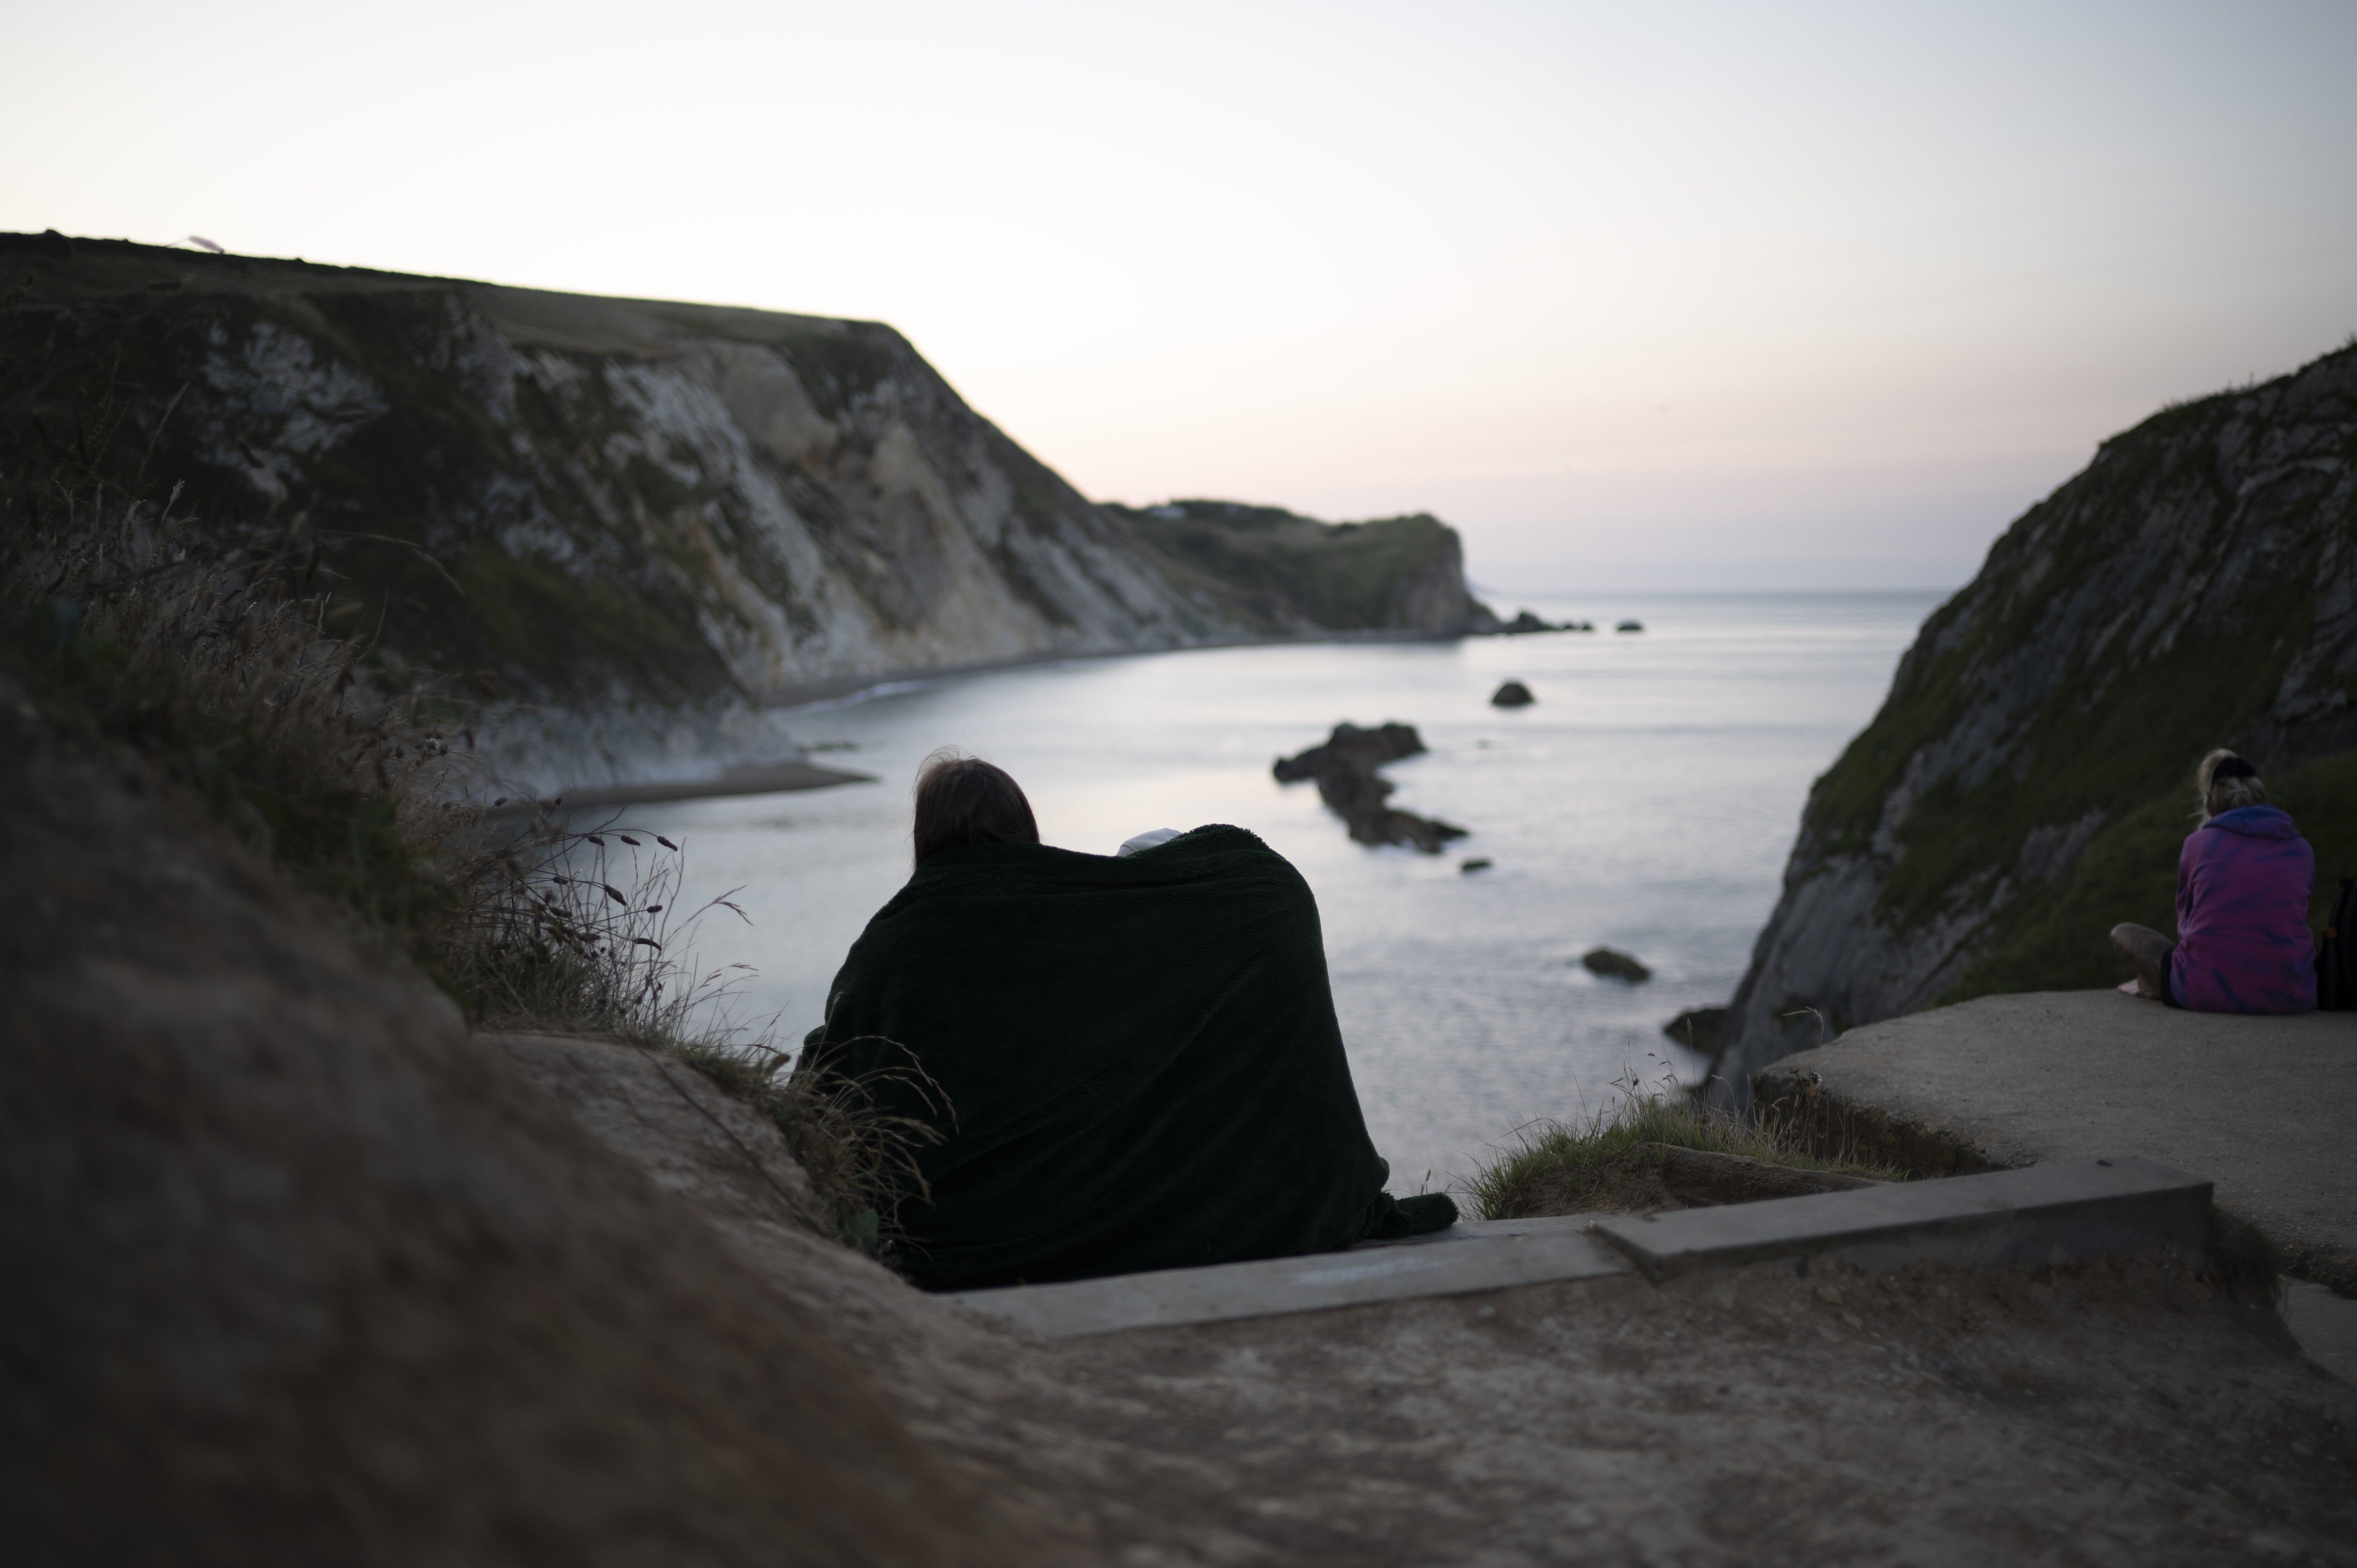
797;754;1457;1290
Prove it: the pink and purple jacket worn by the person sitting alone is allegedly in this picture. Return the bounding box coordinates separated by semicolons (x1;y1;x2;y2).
2168;806;2317;1012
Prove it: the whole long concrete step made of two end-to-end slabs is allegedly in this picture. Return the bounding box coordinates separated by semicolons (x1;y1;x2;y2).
952;1155;2211;1339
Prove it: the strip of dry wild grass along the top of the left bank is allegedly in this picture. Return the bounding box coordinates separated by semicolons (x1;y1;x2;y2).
0;373;933;1252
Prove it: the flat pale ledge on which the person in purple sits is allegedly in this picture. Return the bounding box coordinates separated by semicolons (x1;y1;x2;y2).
1756;990;2357;1294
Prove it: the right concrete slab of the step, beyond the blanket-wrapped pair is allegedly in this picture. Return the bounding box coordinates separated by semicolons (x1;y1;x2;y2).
1595;1155;2211;1283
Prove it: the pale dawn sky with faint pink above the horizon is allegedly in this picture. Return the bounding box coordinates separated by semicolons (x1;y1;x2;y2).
0;0;2357;597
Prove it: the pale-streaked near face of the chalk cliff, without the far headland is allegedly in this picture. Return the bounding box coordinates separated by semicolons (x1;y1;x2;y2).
46;247;1249;703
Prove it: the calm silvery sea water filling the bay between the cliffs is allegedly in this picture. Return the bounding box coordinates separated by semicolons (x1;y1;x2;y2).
599;592;1942;1191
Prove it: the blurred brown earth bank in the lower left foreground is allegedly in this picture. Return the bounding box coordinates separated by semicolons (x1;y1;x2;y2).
0;677;1053;1563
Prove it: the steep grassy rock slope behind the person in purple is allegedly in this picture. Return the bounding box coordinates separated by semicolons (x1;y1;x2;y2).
1716;349;2357;1101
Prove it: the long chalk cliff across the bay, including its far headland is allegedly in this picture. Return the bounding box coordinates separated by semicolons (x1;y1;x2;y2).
0;233;1478;783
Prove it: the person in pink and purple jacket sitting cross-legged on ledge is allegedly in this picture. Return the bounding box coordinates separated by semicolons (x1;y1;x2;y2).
2112;752;2317;1012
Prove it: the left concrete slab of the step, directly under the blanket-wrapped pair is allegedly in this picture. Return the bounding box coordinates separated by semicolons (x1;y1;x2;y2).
950;1217;1629;1339
